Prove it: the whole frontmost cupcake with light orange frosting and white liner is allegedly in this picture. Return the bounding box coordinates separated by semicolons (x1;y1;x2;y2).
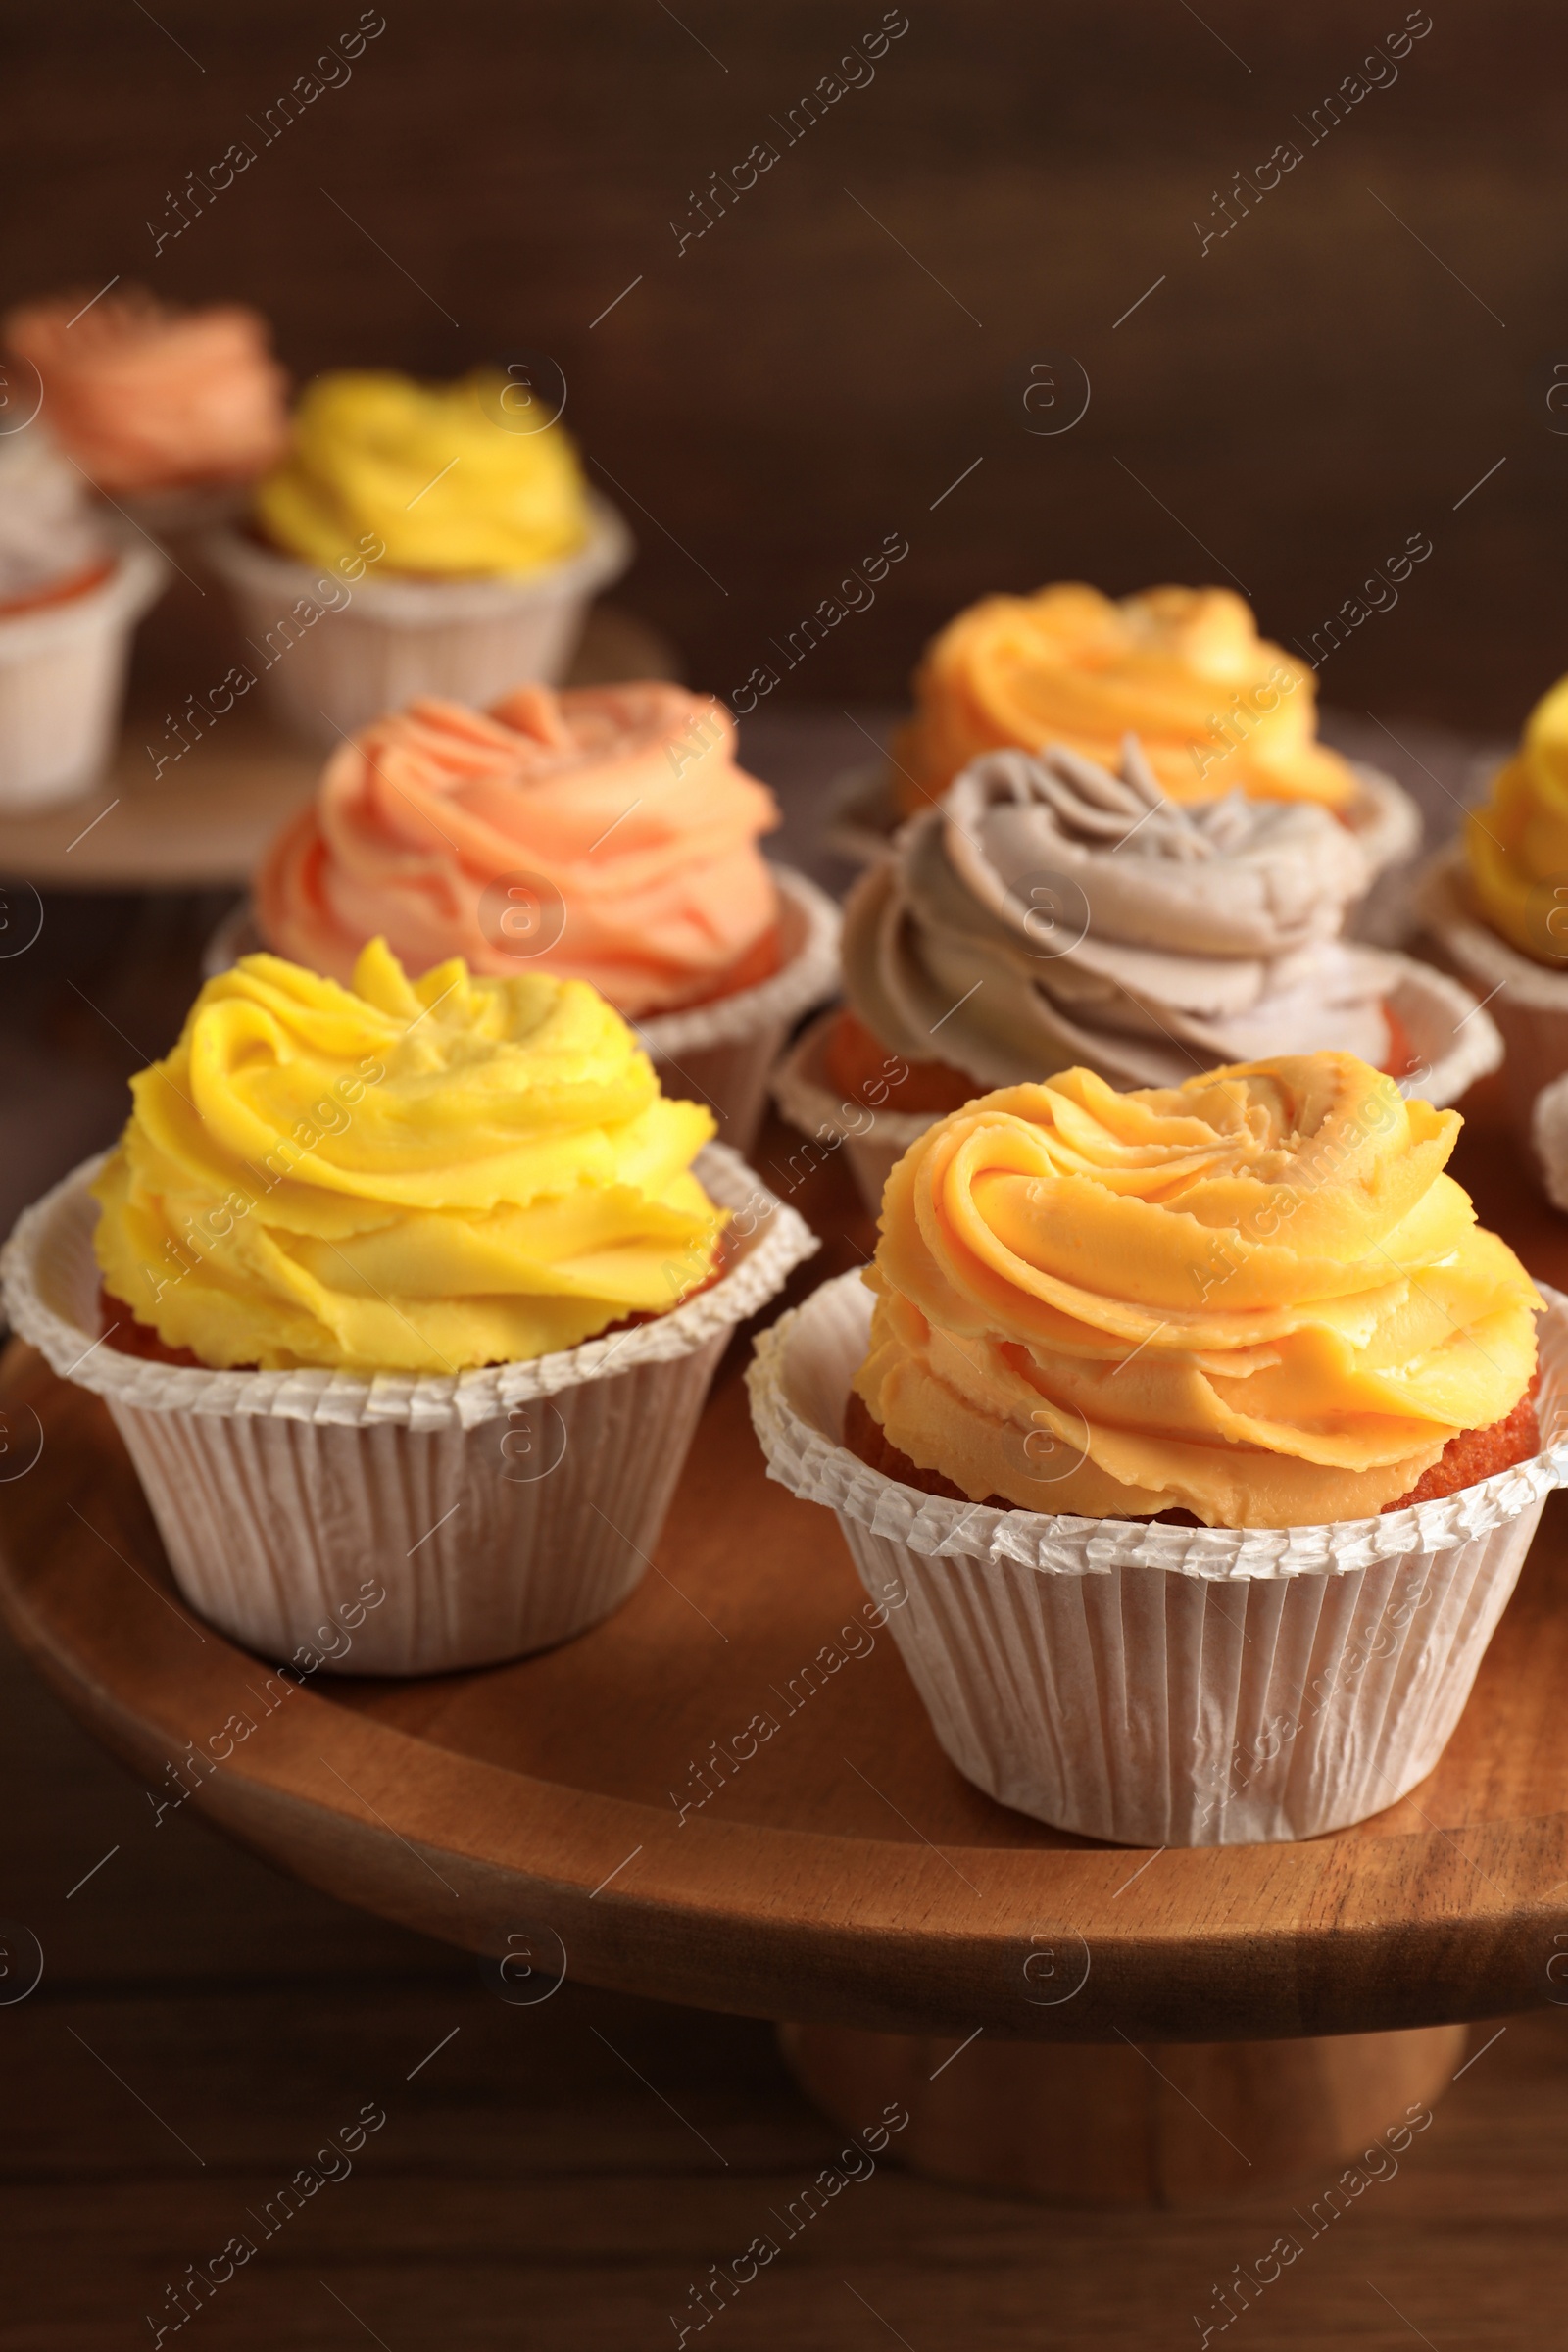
753;1054;1568;1846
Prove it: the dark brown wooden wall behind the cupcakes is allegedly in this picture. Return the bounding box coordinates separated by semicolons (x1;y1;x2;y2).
2;0;1568;731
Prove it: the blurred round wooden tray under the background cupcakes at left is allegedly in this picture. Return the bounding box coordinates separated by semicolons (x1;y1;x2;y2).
0;605;679;892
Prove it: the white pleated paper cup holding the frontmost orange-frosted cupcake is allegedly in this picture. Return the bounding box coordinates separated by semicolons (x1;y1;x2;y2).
748;1275;1568;1846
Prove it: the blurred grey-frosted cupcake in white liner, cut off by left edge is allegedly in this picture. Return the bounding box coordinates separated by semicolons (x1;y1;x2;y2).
0;423;167;811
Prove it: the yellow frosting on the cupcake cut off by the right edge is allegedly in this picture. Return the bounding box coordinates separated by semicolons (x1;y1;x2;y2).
1464;677;1568;964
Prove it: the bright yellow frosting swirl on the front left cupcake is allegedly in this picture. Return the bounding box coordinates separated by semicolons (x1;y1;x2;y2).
94;941;724;1374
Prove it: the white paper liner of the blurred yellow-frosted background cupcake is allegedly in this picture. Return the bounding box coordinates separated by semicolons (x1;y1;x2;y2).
202;494;635;746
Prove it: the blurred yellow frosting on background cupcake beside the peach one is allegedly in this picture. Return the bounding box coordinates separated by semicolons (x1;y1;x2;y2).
254;369;588;578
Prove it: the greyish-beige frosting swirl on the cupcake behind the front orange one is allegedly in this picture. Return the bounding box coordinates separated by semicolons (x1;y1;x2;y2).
844;736;1394;1087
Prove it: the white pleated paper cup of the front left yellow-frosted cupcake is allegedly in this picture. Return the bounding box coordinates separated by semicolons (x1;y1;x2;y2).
0;1146;818;1675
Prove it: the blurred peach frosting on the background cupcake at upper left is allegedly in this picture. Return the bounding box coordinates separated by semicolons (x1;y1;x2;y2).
5;287;289;492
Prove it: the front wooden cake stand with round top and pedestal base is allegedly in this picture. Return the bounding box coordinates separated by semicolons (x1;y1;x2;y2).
0;1099;1568;2204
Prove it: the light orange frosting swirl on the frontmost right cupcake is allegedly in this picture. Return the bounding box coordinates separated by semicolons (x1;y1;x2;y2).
856;1054;1540;1527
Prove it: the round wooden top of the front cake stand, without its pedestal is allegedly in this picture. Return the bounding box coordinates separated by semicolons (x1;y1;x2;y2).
0;1105;1568;2041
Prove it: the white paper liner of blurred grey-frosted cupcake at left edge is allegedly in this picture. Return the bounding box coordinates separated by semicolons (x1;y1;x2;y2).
0;541;170;813
